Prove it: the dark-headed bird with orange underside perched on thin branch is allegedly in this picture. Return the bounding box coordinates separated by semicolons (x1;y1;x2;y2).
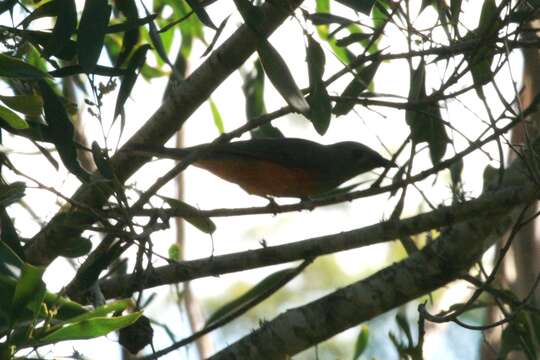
133;138;395;200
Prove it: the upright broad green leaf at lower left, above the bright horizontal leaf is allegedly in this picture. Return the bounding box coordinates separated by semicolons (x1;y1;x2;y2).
11;263;45;323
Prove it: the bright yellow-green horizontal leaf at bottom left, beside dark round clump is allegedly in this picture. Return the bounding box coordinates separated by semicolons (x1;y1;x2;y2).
33;312;142;346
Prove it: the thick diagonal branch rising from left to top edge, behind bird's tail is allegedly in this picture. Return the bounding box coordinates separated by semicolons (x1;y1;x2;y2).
25;0;302;265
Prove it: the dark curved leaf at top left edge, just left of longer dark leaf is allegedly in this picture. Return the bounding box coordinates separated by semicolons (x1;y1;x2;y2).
43;0;77;57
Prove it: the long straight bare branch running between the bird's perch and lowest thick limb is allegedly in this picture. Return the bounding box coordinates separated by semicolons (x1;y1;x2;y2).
100;184;538;298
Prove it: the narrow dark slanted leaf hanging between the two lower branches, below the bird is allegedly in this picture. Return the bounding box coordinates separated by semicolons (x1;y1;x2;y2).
205;268;298;327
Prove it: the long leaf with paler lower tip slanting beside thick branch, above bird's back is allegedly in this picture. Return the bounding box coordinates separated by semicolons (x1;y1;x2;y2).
257;38;309;113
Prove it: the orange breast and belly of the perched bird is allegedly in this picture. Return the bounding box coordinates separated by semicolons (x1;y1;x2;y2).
194;159;319;197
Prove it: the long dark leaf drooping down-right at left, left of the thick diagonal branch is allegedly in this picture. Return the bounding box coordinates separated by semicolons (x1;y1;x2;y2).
38;80;89;182
